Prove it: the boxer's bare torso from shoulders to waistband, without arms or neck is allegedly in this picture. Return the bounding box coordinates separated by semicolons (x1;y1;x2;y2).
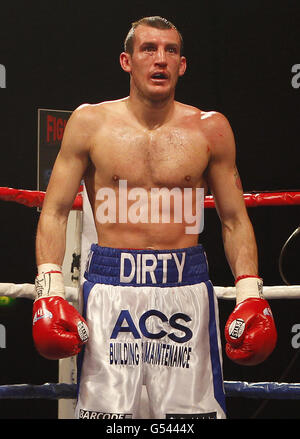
85;98;209;249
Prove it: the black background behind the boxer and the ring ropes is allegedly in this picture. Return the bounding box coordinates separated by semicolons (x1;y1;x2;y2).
0;0;300;419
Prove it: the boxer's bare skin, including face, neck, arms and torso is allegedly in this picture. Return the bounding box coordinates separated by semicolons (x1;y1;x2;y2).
36;26;257;276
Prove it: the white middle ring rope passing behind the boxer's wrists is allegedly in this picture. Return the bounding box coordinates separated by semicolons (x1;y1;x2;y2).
0;283;300;302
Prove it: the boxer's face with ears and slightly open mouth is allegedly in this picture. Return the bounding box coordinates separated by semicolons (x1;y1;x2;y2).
122;25;186;101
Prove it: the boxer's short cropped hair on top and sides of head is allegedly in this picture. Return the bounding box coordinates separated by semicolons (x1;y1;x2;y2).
124;15;183;55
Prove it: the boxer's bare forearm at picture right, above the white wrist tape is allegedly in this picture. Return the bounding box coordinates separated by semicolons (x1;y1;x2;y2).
222;219;258;278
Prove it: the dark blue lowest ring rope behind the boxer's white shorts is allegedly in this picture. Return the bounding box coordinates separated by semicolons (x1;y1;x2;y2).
0;381;300;400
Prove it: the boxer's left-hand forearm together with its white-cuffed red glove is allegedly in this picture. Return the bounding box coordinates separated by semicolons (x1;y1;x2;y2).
32;213;89;360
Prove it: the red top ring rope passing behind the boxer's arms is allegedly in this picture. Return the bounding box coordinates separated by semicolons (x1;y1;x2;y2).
0;187;300;210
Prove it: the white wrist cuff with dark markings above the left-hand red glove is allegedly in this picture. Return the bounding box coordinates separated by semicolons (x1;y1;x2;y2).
35;264;65;300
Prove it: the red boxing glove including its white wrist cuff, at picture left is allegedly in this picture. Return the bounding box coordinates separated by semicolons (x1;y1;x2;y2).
32;264;88;360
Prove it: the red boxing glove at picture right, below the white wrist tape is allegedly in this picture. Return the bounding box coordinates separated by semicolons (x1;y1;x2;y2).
225;298;277;366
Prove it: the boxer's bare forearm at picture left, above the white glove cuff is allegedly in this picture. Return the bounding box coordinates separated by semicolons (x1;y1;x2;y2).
36;212;67;266
